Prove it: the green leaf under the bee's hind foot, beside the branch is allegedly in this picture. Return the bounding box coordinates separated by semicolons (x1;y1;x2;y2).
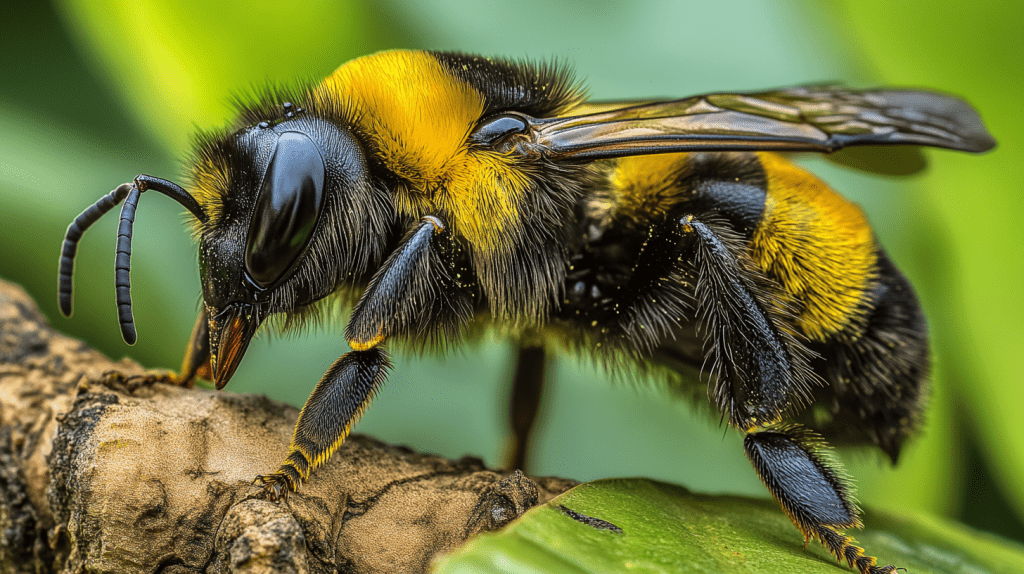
433;479;1024;574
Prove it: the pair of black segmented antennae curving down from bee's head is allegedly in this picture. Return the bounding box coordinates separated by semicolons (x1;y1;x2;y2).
57;175;209;345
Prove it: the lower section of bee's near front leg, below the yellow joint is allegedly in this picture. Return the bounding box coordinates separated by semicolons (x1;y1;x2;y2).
255;347;391;500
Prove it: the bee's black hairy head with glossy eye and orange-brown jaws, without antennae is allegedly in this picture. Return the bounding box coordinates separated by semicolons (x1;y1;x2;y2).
193;113;391;387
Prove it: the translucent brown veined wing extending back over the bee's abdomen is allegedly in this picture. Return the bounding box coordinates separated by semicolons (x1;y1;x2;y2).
520;86;995;162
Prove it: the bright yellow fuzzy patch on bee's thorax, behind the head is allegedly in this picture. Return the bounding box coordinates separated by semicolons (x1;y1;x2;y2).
312;51;529;252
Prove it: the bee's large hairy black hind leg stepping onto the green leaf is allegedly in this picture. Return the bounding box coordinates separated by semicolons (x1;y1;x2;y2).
680;216;895;574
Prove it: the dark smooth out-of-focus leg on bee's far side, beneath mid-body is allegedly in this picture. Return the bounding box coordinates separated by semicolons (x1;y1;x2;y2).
506;344;545;472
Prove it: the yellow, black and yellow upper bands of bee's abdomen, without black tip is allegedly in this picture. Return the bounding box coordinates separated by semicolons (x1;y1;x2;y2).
605;152;878;341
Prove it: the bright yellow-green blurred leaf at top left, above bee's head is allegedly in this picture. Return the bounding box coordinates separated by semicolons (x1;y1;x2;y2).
62;0;391;154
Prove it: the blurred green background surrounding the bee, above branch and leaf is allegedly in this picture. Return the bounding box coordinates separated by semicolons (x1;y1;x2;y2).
0;0;1024;540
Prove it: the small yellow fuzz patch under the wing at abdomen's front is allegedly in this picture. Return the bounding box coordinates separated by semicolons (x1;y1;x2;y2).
611;153;686;220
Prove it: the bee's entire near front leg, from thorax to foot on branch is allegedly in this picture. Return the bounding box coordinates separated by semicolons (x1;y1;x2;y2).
256;216;464;500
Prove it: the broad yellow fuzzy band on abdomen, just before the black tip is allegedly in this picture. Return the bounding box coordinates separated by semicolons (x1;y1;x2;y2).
750;152;877;341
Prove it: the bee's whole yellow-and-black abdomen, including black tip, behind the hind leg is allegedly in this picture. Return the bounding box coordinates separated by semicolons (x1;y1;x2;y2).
585;148;929;448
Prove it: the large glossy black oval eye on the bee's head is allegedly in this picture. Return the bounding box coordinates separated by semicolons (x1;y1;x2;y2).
246;132;326;288
